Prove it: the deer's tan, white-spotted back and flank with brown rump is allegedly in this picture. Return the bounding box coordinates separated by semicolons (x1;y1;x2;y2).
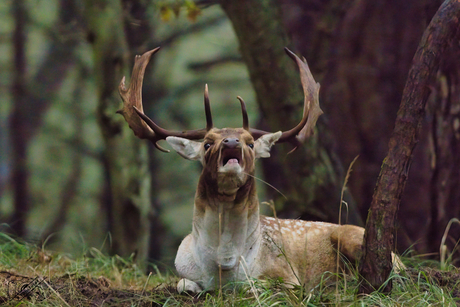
259;216;364;286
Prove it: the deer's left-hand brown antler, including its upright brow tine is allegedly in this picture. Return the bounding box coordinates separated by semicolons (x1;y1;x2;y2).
117;47;212;152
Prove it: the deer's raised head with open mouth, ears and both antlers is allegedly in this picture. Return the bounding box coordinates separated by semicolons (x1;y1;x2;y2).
118;48;322;199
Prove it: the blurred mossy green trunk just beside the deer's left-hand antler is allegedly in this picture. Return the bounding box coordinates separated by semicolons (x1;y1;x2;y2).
85;0;150;263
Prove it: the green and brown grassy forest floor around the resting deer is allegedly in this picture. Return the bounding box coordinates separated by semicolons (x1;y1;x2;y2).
0;233;460;306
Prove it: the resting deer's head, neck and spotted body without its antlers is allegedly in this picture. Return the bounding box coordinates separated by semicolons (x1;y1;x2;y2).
166;129;364;292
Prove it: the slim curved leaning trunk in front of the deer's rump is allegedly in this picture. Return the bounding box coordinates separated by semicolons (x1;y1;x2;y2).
359;0;460;293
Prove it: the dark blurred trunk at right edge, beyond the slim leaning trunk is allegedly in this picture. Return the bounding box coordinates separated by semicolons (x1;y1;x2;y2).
427;31;460;260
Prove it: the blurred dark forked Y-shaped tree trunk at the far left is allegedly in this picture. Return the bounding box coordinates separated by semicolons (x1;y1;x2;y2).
8;0;80;236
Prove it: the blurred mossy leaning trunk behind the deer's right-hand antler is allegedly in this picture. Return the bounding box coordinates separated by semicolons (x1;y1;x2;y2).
221;0;361;224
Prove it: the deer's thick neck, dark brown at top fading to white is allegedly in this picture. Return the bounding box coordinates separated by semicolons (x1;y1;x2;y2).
192;178;260;269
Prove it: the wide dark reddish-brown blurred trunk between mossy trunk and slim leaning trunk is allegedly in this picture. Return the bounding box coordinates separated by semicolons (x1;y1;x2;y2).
316;0;435;221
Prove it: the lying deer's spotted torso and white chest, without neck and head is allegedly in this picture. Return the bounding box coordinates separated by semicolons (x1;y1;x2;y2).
176;216;364;292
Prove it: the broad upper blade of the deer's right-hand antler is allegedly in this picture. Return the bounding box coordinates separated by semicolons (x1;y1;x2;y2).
248;48;323;147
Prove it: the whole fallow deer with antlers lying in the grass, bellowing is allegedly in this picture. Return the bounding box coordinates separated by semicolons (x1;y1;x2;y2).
118;48;392;292
